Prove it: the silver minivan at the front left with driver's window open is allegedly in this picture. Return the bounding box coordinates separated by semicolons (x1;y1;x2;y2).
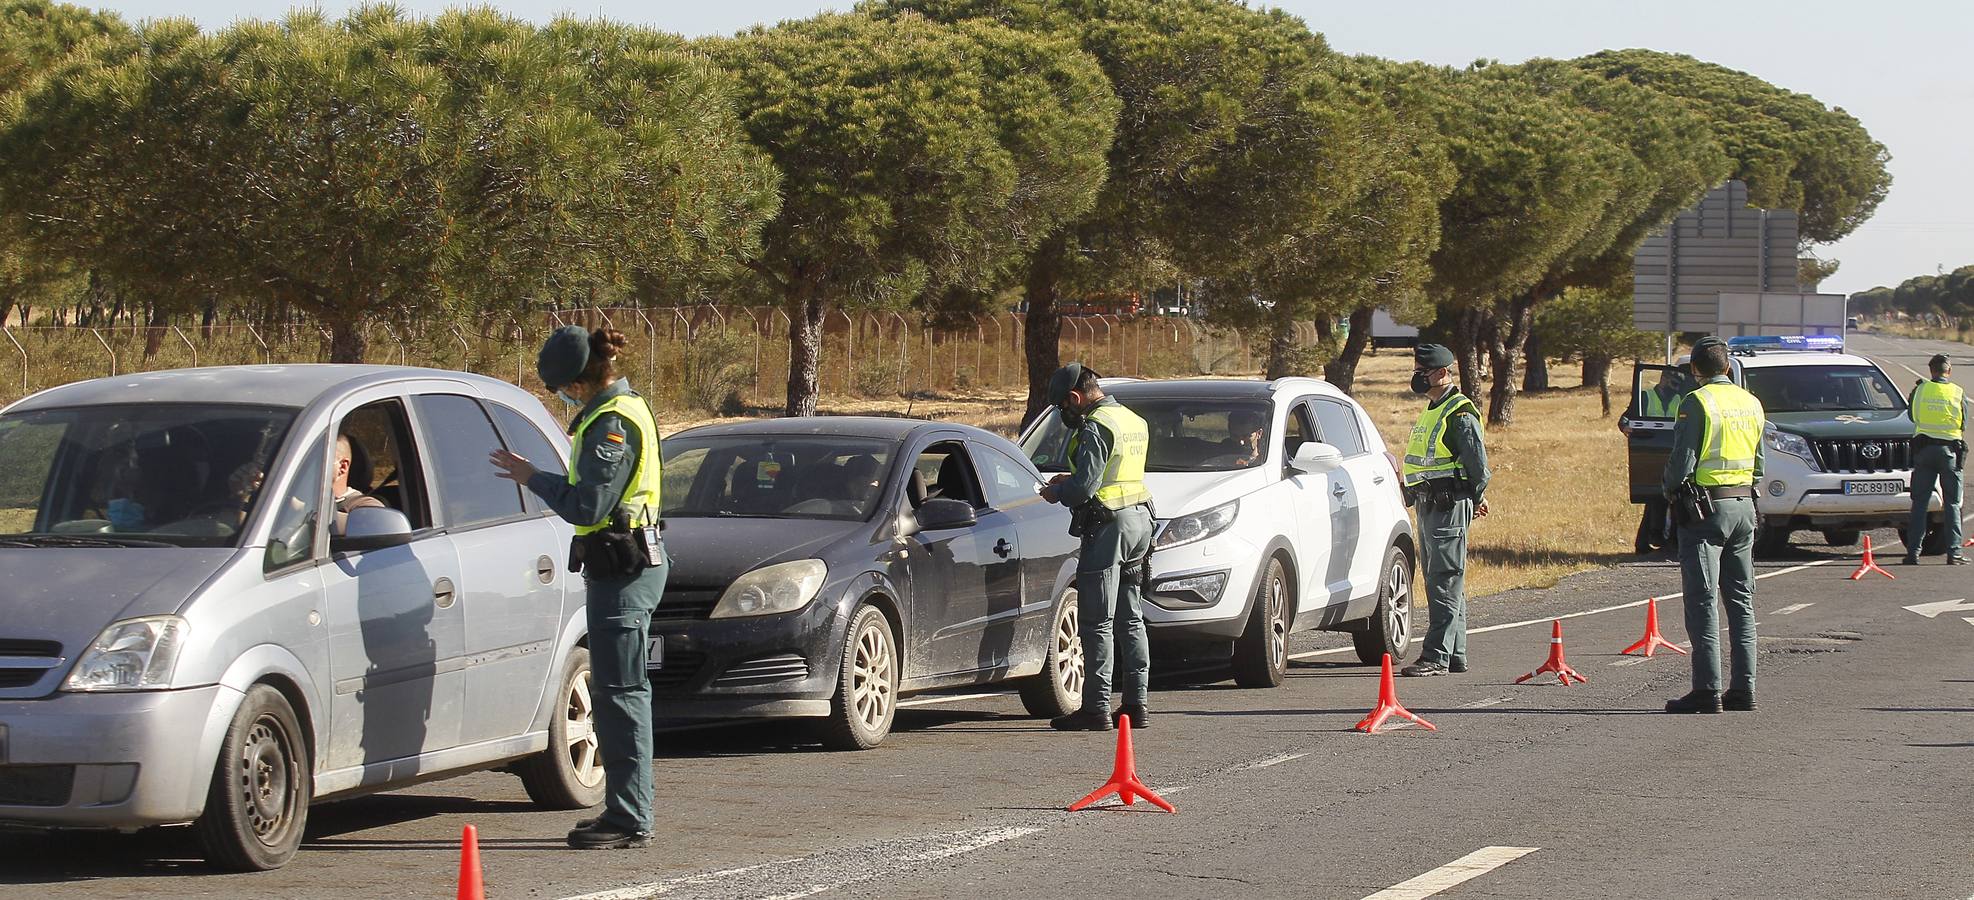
0;365;604;868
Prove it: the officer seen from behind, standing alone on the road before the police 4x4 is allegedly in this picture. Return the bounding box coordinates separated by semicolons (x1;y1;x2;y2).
1662;336;1767;713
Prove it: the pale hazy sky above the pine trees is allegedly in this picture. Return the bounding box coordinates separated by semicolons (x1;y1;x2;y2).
71;0;1974;294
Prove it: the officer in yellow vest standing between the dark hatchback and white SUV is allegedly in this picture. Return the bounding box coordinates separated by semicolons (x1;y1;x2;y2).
1040;363;1151;730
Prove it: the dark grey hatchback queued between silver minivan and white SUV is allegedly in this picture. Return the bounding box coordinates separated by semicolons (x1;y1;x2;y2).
651;416;1084;750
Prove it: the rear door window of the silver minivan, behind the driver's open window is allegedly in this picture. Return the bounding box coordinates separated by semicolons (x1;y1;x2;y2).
413;395;525;529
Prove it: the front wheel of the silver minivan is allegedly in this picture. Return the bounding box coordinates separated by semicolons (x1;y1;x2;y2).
191;685;316;872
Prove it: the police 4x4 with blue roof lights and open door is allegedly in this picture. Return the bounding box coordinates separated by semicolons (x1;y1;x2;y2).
1629;347;1944;557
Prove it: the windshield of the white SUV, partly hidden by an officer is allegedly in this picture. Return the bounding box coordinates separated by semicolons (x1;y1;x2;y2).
1021;399;1269;472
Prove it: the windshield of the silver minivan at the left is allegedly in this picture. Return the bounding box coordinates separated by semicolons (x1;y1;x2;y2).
0;403;294;547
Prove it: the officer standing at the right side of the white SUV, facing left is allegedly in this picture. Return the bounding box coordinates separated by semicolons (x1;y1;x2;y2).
1400;343;1488;677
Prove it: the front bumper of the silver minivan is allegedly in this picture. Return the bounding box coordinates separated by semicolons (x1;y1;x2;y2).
0;685;243;829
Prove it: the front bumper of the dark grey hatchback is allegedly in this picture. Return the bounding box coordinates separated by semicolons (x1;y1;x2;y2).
651;602;843;718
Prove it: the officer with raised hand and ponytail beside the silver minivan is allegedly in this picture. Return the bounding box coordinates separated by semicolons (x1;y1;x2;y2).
492;326;665;851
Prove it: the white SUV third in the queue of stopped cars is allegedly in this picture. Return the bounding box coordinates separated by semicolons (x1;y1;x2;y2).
1021;379;1417;687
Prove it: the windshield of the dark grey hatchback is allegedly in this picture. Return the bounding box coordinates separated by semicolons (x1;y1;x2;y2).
661;434;898;521
